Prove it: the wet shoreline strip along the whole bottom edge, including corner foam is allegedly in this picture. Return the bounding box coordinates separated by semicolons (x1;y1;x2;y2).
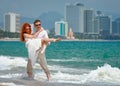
0;78;119;86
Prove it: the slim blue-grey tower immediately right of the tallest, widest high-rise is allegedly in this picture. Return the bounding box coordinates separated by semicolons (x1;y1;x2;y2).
84;9;94;34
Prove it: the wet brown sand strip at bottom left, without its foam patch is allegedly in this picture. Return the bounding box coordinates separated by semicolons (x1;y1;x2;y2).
0;78;82;86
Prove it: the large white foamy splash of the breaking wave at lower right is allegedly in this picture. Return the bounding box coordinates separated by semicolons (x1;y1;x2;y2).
84;64;120;83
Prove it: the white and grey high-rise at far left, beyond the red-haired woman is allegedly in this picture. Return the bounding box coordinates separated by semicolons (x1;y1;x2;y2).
4;13;20;32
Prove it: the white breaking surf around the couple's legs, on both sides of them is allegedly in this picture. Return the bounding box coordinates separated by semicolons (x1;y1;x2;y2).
0;56;120;84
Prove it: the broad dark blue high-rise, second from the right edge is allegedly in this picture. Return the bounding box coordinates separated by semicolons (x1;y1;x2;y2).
96;15;112;36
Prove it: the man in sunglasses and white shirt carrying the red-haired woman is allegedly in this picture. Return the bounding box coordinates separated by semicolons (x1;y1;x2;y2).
27;20;50;80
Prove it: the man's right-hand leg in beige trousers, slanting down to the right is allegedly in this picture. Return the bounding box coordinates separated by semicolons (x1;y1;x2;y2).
38;53;50;80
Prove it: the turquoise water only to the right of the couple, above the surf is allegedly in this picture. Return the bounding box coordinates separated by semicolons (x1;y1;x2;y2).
47;41;120;68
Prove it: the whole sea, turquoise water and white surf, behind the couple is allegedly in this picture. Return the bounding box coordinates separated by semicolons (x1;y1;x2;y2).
0;41;120;86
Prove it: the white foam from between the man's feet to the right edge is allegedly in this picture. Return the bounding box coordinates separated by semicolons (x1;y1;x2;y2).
35;64;120;84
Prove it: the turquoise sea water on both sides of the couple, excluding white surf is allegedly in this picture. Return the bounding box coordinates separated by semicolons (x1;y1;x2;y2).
0;41;120;69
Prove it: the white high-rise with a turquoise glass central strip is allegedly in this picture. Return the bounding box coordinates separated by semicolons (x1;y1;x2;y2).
55;21;68;37
